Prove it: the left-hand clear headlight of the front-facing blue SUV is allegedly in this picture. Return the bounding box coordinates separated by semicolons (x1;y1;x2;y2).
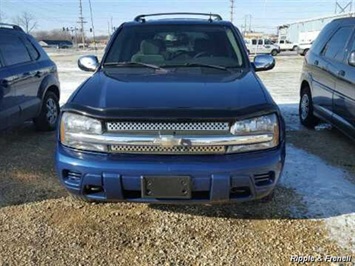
60;113;107;152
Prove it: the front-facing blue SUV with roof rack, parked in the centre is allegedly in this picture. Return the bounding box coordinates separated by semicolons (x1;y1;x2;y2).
56;13;285;203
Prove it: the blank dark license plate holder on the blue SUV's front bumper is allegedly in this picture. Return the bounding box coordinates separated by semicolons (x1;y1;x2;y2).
141;176;191;199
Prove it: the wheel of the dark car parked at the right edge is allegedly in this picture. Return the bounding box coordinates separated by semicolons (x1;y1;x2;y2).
299;87;319;128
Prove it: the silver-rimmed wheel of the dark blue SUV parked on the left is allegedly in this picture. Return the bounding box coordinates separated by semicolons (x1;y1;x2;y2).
33;91;60;131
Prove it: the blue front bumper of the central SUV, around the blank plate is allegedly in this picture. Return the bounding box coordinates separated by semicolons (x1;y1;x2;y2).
56;143;285;204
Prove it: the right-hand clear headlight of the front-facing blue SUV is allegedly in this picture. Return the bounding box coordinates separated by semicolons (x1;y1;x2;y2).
227;114;280;153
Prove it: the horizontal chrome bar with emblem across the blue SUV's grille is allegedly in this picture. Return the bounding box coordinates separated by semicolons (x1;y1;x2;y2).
67;133;274;147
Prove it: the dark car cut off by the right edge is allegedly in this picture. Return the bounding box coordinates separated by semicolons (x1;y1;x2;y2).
299;18;355;140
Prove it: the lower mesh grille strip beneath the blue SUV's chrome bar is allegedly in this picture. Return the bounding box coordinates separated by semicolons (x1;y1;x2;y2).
111;145;226;154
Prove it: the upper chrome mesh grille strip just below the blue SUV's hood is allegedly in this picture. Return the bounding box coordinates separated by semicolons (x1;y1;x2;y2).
106;122;229;132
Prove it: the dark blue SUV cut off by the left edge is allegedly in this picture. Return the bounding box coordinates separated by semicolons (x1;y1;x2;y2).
0;23;60;131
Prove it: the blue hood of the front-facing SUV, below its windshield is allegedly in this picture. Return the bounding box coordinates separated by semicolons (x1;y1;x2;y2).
68;71;277;118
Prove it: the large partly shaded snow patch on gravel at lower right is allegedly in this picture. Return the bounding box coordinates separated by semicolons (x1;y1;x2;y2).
281;145;355;252
